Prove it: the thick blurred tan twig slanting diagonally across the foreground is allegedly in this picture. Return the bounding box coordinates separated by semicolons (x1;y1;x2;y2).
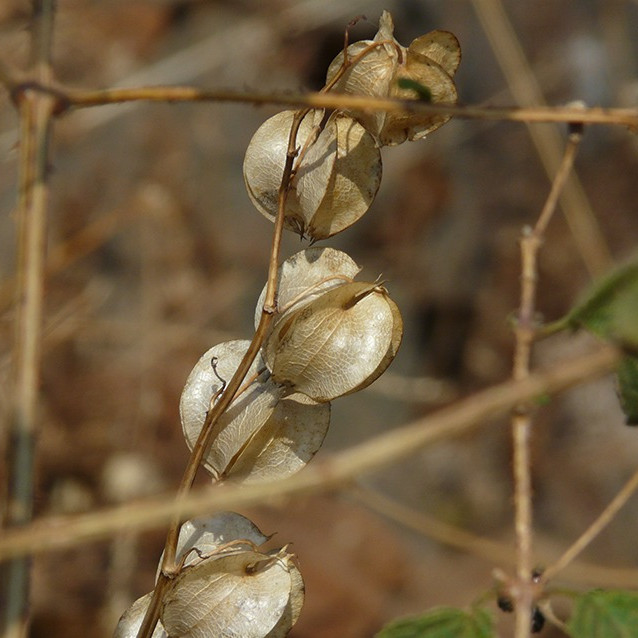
0;346;622;560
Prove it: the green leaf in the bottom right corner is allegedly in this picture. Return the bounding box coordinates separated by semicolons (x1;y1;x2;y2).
567;590;638;638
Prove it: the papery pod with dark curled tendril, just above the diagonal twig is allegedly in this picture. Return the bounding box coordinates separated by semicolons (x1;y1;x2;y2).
180;341;330;483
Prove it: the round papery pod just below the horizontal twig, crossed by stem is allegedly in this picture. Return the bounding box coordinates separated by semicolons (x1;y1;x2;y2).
244;111;381;240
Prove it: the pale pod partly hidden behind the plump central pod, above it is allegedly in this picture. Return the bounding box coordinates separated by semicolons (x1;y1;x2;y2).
255;247;361;328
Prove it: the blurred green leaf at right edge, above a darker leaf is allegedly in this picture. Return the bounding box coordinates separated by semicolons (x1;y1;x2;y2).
567;259;638;349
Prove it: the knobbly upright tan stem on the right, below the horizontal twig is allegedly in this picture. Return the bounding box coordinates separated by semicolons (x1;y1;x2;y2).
512;127;582;638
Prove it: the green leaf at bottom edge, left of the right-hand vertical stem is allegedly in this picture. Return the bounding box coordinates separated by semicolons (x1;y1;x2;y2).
376;607;495;638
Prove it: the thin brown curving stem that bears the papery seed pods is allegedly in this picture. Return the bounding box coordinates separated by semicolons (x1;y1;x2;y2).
137;109;308;638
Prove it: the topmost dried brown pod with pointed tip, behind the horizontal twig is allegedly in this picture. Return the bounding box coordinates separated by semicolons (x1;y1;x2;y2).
327;11;461;146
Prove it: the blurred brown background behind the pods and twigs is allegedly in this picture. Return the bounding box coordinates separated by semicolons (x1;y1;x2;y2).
0;0;638;638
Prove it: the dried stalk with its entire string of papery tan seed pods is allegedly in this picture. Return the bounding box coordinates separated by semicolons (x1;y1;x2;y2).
115;12;460;638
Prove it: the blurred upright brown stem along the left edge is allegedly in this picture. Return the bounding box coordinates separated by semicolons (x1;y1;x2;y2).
2;0;55;638
